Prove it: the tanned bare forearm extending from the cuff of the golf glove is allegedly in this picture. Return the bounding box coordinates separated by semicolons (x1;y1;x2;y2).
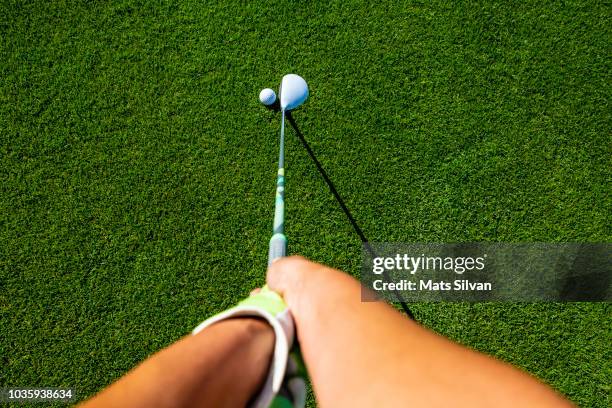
84;319;274;408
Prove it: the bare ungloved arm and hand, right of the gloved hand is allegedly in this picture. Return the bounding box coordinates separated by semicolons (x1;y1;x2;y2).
269;259;567;407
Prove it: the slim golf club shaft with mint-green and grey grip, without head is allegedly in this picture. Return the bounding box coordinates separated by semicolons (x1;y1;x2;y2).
268;110;287;266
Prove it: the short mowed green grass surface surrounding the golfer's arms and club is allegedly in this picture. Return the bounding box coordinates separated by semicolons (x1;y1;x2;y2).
0;1;612;407
